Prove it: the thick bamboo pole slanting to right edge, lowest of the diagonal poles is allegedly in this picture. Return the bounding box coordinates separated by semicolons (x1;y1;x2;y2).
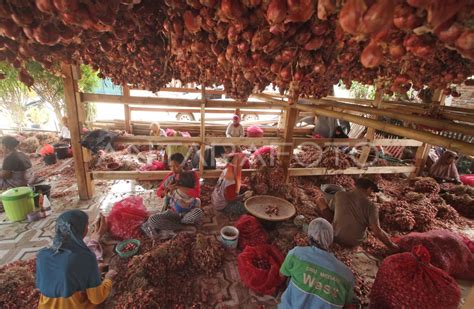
296;103;474;155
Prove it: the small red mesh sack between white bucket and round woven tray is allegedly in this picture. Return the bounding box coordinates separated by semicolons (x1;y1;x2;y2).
235;215;268;250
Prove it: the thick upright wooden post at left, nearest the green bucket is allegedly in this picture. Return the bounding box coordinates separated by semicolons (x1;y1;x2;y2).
61;63;94;200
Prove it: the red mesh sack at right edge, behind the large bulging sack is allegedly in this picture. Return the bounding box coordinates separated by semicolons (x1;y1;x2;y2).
397;230;474;280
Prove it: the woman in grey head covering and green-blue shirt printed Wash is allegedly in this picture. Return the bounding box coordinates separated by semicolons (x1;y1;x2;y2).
278;218;354;309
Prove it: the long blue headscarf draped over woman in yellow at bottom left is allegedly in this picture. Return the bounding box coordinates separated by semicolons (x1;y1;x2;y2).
36;210;101;298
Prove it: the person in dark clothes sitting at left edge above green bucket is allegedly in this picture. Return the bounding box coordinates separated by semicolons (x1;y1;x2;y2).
0;136;33;190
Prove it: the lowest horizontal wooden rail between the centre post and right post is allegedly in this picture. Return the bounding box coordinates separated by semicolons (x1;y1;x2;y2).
289;166;416;177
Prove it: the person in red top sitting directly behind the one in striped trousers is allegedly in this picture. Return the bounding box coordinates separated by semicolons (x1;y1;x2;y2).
156;153;201;209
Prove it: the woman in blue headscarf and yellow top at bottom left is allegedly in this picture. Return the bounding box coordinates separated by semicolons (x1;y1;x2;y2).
36;209;117;309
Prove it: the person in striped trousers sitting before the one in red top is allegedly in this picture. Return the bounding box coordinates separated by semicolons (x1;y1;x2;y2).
142;172;204;237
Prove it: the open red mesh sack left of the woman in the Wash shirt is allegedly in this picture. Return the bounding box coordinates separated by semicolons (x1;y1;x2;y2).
237;244;285;295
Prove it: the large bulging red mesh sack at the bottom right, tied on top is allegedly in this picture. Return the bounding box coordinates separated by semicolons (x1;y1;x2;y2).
369;246;461;309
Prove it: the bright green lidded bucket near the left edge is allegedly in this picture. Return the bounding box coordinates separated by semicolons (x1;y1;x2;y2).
1;187;35;222
